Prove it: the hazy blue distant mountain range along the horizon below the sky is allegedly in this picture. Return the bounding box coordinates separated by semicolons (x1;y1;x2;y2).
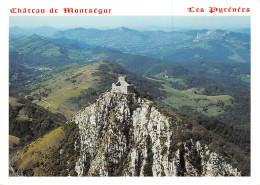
10;27;250;63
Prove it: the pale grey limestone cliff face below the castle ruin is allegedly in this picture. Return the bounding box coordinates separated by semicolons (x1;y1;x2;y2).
74;92;241;176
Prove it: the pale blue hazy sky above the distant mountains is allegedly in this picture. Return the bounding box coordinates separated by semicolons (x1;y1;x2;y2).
9;16;250;29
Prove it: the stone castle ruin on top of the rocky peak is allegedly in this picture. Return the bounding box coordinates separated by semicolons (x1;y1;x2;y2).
111;76;134;94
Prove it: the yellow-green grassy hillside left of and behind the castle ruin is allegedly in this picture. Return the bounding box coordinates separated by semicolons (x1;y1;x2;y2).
31;63;100;118
